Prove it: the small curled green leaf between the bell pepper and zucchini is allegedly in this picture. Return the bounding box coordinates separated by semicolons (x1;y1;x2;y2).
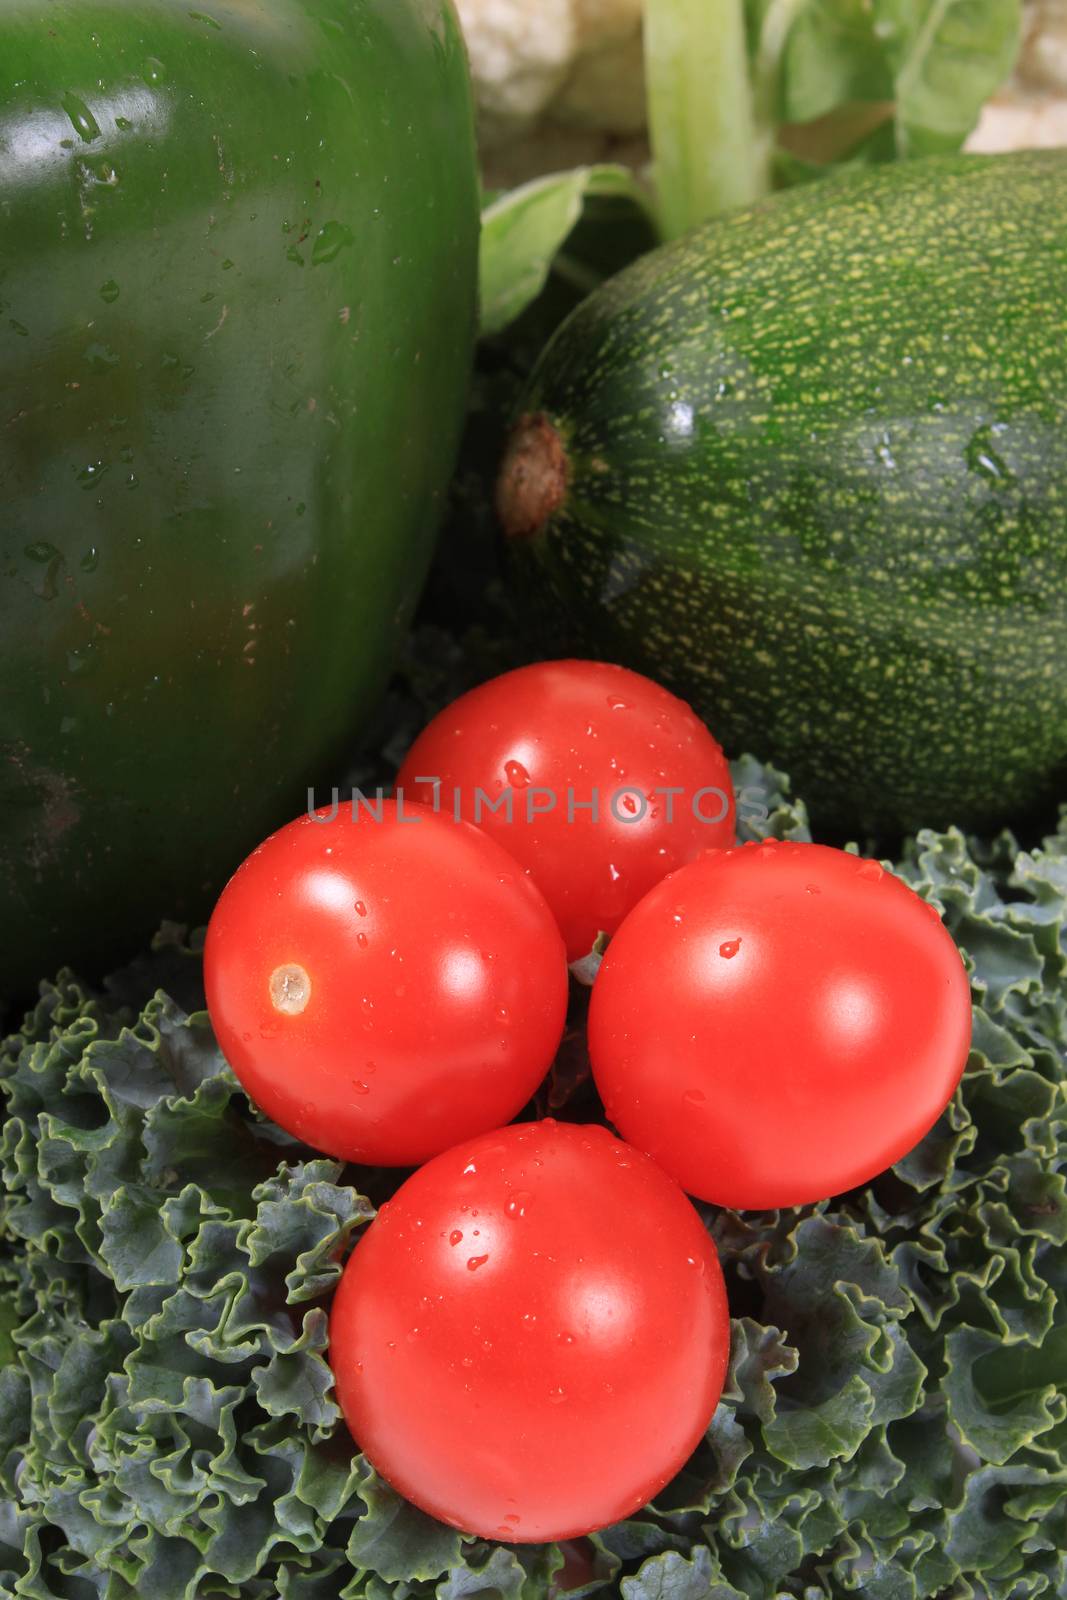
478;166;651;334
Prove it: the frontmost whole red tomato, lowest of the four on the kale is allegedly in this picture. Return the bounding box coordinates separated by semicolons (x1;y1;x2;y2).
330;1122;729;1542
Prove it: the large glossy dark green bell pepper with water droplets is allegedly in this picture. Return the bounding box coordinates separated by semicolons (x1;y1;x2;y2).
0;0;478;994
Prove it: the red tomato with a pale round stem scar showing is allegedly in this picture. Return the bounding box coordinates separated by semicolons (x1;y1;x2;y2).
205;800;566;1166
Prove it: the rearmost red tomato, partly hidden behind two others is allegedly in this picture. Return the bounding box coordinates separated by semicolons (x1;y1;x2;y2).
397;661;734;962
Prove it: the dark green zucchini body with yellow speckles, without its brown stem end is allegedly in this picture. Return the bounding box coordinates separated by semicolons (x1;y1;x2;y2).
512;152;1067;829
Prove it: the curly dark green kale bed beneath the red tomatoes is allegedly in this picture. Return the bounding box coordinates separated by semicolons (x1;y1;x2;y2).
0;755;1067;1600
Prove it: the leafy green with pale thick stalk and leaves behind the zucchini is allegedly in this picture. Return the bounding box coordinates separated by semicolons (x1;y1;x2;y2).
617;0;1021;238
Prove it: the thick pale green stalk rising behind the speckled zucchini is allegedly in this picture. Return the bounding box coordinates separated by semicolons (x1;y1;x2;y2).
645;0;771;238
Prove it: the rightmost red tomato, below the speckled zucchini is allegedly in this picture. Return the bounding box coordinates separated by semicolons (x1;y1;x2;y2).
589;843;971;1210
